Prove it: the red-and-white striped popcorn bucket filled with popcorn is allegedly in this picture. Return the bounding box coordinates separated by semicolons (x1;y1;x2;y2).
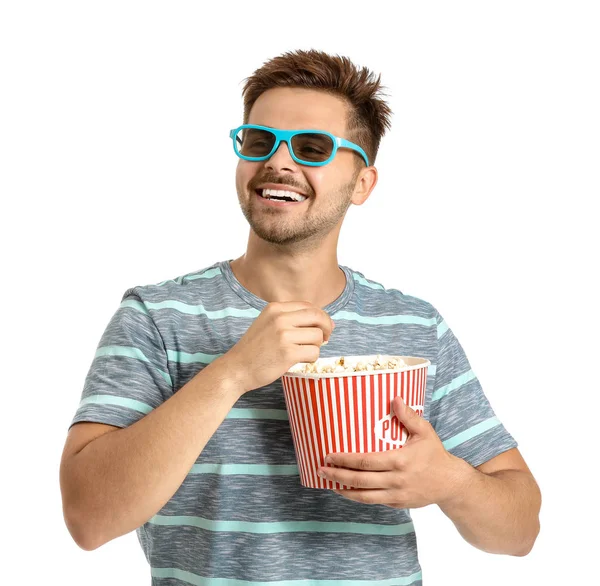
282;355;431;489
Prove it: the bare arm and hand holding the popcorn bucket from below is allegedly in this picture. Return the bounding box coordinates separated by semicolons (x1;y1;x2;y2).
320;397;541;556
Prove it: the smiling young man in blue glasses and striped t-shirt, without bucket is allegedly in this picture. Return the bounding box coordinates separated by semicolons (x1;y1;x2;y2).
60;51;540;586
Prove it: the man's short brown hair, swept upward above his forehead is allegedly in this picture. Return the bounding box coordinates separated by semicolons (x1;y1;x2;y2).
242;49;392;165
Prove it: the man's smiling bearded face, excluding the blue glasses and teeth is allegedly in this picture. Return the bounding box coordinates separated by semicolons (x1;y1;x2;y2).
236;88;360;245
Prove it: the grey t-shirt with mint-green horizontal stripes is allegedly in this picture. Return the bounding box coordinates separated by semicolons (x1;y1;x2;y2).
73;261;517;586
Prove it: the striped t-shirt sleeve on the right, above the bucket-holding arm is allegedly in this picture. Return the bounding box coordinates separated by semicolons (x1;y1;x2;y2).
429;311;518;466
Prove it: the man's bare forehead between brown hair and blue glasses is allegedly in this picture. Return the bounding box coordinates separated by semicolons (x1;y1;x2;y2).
248;87;348;137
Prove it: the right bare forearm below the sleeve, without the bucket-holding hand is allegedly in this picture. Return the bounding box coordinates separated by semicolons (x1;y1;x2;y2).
439;458;541;556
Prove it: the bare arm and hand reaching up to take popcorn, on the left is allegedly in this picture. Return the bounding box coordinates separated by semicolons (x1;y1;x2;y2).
60;301;334;550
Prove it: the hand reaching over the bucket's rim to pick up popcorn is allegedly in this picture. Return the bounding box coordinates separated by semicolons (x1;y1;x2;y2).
221;301;335;393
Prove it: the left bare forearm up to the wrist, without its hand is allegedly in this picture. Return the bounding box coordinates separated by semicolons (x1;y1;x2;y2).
64;360;242;549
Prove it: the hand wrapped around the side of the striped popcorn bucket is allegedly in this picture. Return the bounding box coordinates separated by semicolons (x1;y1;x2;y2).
320;397;468;509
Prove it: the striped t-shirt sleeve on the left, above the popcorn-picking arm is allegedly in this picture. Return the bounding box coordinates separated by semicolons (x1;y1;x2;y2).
69;288;173;428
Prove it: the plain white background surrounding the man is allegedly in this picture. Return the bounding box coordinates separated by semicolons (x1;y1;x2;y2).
0;0;600;586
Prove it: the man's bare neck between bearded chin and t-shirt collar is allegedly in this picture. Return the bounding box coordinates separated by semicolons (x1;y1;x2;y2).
230;230;346;308
